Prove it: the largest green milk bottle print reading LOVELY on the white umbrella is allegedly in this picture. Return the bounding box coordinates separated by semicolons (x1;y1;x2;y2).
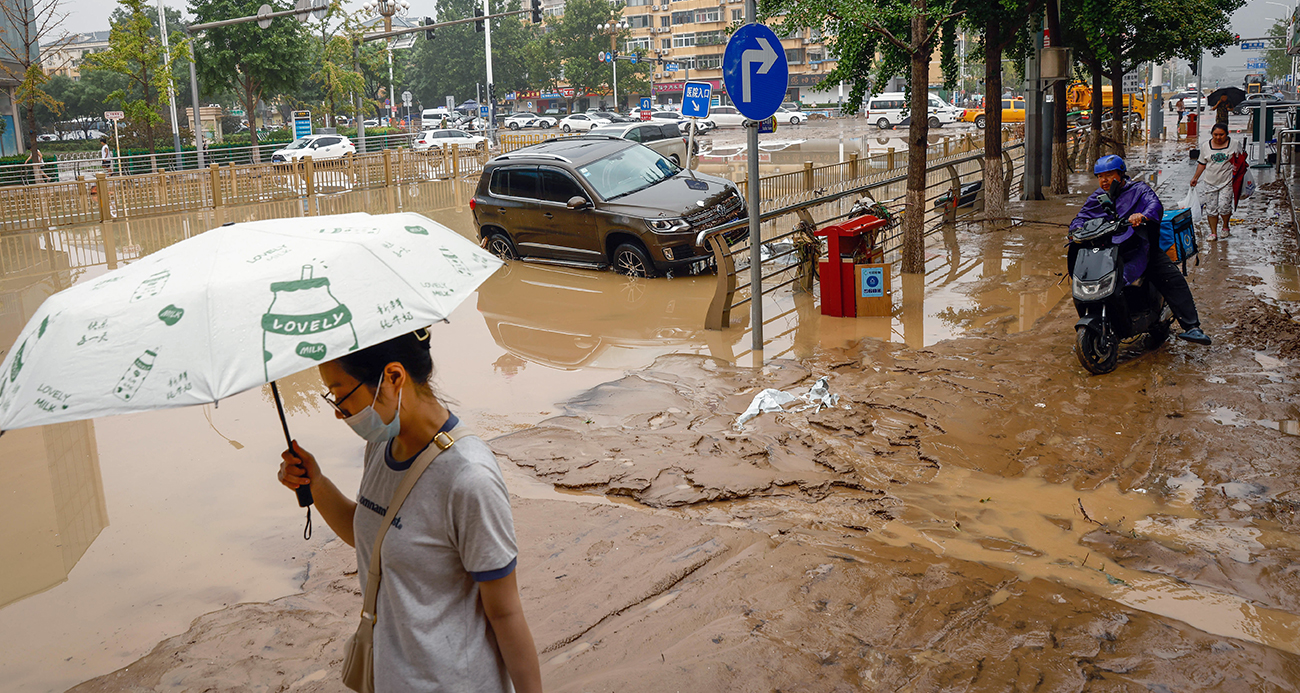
261;265;358;382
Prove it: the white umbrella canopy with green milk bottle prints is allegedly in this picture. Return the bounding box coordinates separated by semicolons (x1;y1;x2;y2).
0;213;502;520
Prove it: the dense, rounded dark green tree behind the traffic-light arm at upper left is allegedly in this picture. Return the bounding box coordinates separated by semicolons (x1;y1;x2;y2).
190;0;312;154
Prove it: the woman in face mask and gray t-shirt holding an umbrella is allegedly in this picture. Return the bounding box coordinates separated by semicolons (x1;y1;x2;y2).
280;329;542;693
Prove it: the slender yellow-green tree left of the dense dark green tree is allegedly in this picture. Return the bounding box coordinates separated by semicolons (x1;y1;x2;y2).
82;0;190;152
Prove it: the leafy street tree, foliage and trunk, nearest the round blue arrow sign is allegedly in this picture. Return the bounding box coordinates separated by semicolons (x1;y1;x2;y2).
759;0;961;273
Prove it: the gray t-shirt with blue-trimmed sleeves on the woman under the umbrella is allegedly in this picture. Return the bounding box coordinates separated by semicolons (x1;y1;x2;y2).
352;426;517;693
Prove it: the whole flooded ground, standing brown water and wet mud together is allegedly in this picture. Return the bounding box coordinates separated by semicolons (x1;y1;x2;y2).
10;132;1300;690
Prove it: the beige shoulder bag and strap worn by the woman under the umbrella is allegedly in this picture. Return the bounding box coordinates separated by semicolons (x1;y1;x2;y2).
343;426;468;693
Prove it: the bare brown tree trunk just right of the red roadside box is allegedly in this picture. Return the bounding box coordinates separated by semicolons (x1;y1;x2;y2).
899;0;931;273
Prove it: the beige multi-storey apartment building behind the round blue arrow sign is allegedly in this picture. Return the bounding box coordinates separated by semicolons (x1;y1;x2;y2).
623;0;835;104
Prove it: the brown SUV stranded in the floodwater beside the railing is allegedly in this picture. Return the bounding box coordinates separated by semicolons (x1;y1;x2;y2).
469;135;746;277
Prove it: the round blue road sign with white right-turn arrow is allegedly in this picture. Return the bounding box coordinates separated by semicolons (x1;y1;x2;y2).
723;23;790;121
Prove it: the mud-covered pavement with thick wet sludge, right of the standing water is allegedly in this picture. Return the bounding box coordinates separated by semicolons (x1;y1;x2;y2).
48;139;1300;692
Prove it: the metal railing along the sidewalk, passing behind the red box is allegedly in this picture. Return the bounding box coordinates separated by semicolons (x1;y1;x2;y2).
697;130;1024;330
